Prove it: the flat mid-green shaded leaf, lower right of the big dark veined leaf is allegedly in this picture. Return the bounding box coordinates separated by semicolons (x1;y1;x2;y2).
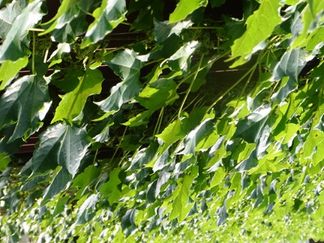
99;168;122;205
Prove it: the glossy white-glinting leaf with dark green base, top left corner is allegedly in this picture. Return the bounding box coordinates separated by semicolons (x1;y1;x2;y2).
0;0;43;62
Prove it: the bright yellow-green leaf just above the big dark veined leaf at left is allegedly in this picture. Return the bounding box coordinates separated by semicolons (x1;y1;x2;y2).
52;70;103;123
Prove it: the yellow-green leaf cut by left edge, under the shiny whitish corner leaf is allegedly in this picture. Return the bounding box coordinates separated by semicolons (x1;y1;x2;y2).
0;57;28;90
